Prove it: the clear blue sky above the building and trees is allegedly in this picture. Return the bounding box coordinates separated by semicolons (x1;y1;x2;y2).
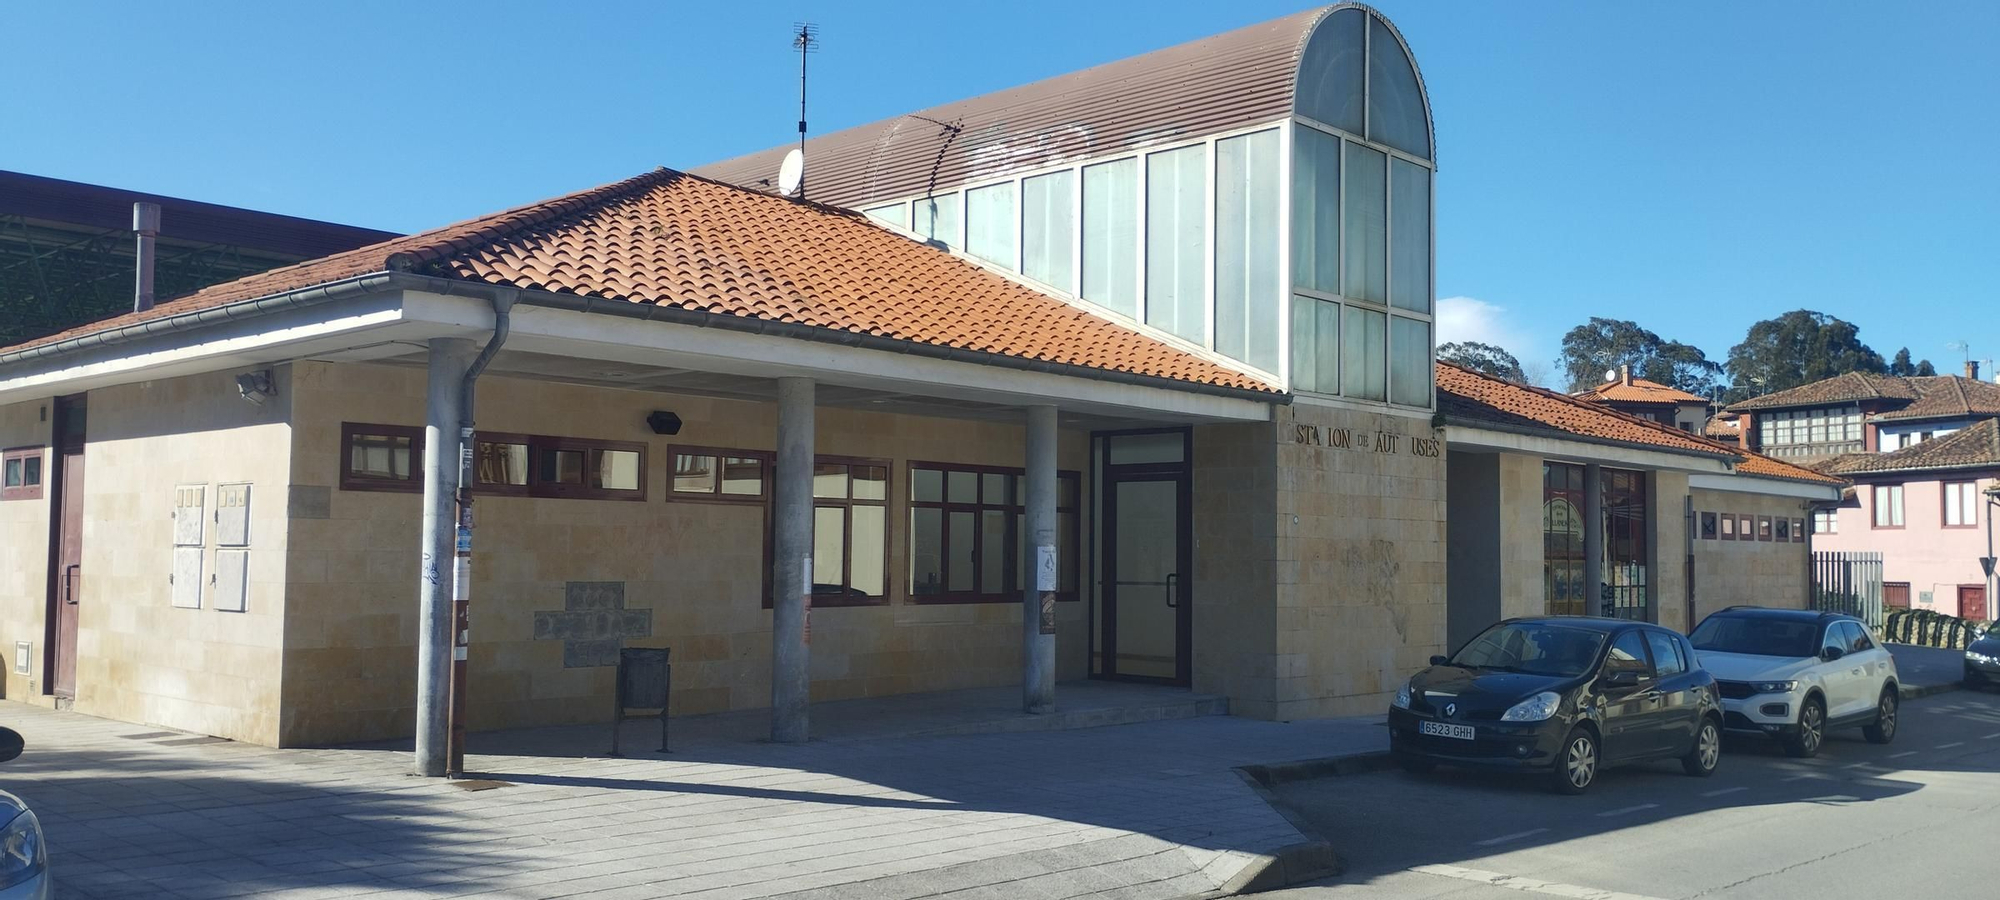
0;0;2000;382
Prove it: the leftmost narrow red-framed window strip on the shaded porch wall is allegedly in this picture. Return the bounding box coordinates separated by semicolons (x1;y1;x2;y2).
340;422;646;500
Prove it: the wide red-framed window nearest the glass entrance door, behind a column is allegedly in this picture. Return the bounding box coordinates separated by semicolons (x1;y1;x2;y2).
908;462;1082;604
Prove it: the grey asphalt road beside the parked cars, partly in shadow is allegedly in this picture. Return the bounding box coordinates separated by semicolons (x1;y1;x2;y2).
1268;690;2000;900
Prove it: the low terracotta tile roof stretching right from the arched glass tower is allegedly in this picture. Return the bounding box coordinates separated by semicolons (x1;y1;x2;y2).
1438;362;1846;486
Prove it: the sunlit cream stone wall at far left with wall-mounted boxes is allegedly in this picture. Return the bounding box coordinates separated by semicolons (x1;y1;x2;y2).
0;366;290;744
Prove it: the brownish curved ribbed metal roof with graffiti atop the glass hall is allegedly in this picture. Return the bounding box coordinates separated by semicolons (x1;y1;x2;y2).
692;4;1428;208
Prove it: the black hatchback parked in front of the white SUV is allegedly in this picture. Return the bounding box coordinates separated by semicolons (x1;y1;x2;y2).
1388;616;1722;794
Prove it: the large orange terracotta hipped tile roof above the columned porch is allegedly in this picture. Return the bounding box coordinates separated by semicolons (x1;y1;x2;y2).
3;168;1276;394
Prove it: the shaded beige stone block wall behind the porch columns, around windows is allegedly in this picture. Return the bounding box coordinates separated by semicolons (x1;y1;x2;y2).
282;364;1088;744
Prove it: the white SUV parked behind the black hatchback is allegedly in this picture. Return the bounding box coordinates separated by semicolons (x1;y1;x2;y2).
1688;606;1902;756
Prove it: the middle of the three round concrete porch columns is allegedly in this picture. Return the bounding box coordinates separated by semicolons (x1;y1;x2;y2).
770;378;814;744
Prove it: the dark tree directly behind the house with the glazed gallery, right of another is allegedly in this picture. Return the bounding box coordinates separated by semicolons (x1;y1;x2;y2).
1726;310;1888;402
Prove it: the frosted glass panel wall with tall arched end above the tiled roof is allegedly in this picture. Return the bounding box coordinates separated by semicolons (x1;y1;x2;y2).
836;8;1436;394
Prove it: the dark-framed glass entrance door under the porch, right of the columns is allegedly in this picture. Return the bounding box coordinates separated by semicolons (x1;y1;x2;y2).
1094;432;1192;684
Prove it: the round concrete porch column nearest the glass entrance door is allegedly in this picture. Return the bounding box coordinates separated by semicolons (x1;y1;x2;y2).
1020;406;1062;714
